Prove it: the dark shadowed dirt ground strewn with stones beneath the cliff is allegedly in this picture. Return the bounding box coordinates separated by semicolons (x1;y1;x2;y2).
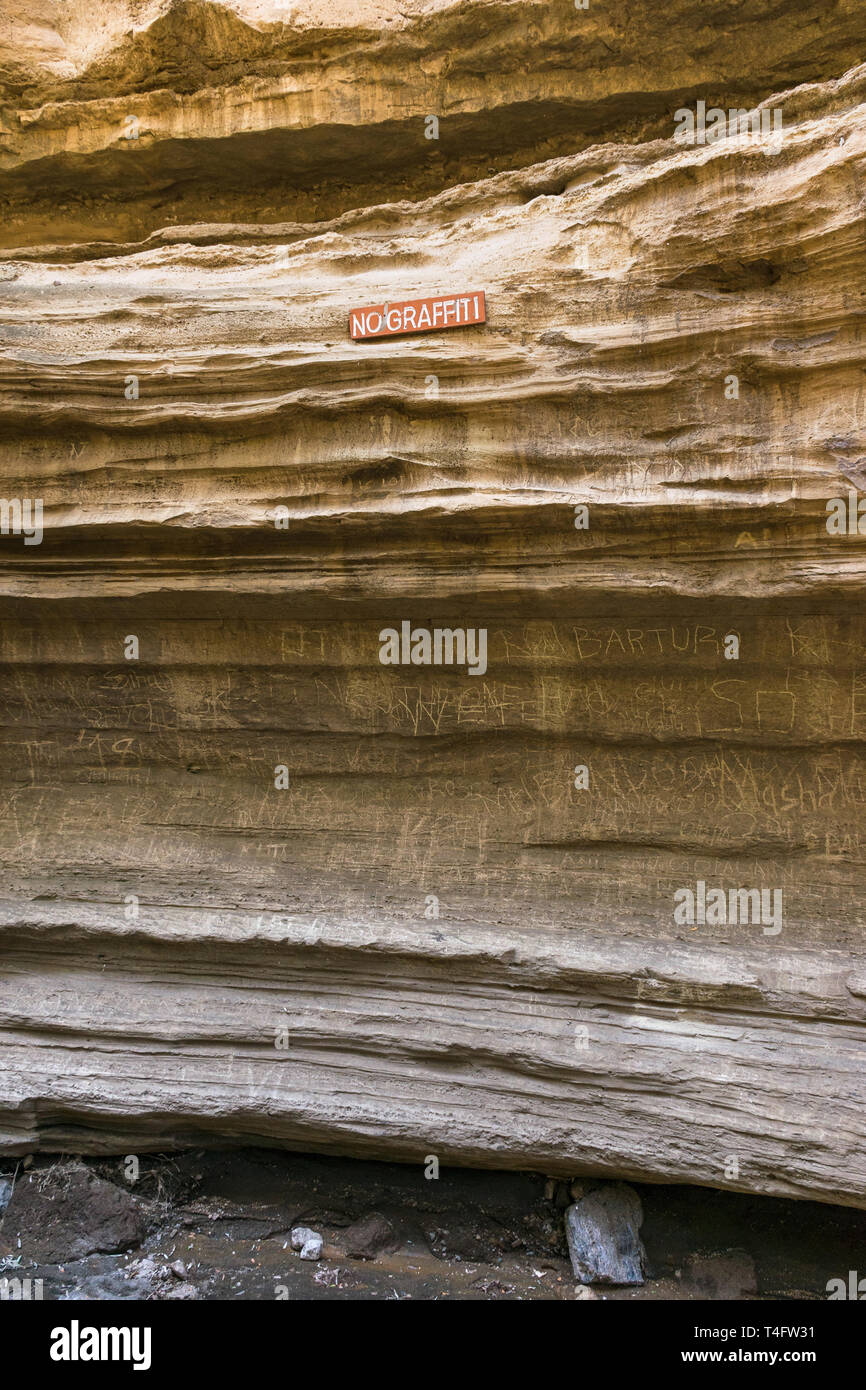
0;1150;866;1300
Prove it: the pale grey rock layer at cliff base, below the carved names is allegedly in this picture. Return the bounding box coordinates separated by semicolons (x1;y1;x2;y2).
0;904;866;1205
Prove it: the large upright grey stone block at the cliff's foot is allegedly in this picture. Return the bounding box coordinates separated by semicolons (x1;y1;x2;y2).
566;1183;646;1284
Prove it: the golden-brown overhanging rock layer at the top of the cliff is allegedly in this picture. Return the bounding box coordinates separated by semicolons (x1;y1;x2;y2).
6;0;863;247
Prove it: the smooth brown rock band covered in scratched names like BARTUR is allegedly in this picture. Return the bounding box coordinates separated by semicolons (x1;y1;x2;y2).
0;616;866;933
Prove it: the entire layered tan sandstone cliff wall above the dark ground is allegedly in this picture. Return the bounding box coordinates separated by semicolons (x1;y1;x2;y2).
0;0;866;1207
